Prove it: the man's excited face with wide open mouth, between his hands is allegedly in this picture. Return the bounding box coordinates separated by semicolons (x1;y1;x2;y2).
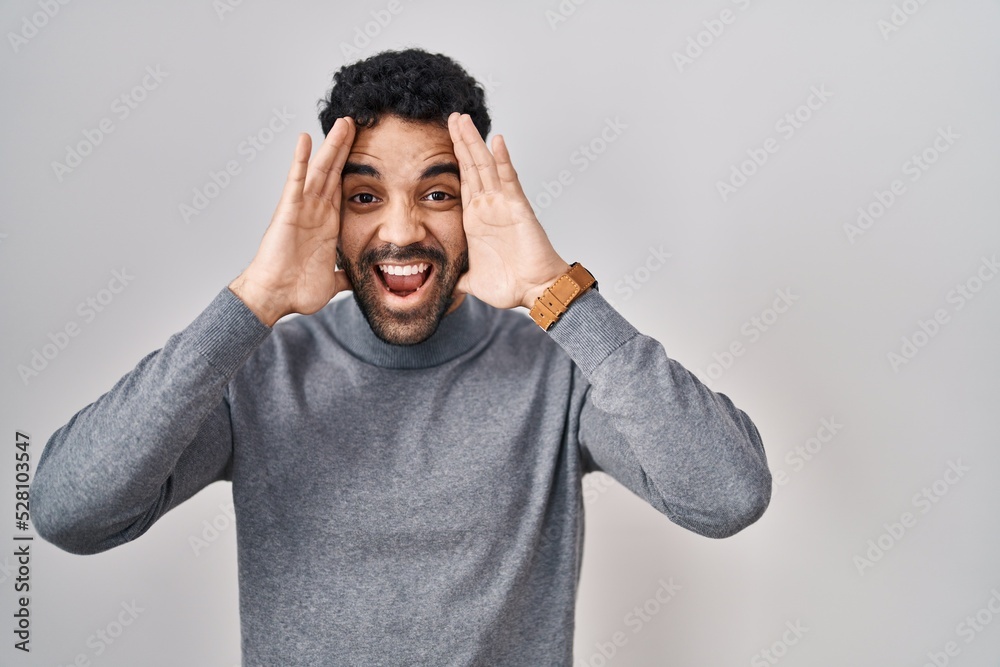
337;116;468;345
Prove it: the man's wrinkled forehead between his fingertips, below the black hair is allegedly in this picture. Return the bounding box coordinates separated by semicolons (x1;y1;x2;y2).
348;116;455;176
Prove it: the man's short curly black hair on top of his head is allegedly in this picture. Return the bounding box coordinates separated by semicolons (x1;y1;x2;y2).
319;49;490;140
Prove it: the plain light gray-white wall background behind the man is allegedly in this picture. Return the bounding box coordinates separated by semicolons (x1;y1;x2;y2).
0;0;1000;667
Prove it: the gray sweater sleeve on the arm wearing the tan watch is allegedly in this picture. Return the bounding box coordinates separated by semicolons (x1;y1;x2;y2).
549;290;771;538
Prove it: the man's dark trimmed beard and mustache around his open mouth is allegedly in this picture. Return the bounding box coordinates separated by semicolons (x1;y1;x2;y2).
337;243;469;345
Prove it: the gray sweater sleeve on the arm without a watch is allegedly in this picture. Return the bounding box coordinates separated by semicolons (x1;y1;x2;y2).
31;287;271;554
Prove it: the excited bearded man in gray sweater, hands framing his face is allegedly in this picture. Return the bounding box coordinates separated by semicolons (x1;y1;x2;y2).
32;49;771;666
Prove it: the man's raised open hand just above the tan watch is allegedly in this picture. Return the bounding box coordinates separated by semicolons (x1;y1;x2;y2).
448;112;570;308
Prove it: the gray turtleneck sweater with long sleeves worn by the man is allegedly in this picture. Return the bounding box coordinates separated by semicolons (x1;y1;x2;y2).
31;288;771;667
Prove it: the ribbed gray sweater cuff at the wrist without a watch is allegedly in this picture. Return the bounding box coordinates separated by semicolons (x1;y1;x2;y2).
186;287;271;377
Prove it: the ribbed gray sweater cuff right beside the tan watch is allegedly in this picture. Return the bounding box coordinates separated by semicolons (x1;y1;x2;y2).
548;289;639;378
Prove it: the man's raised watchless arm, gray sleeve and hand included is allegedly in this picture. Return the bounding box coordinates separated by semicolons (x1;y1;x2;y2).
32;118;355;553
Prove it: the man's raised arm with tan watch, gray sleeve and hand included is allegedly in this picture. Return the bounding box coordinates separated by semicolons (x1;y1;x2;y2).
448;113;771;537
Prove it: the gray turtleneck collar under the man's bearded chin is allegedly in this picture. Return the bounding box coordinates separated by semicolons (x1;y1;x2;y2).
326;294;495;369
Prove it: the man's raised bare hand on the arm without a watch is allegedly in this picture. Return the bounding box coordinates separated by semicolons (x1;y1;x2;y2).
229;117;355;326
